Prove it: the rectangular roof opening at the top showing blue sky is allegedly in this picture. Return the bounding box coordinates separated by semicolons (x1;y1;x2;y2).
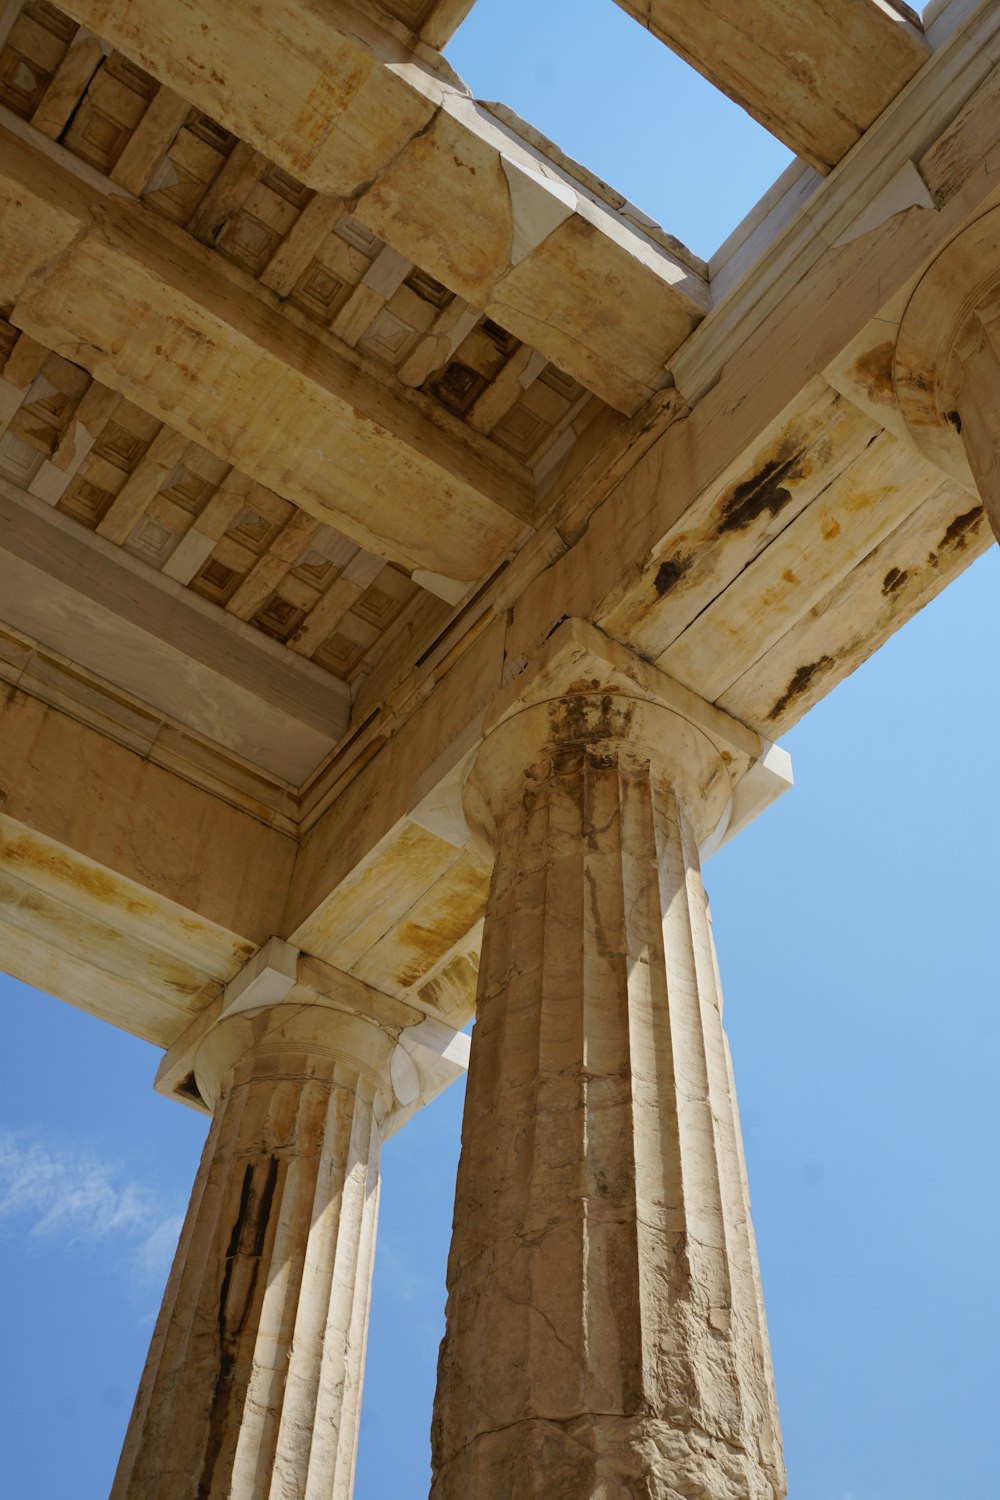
447;0;793;258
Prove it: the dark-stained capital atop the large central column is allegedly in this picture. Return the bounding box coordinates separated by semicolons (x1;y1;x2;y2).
465;620;792;854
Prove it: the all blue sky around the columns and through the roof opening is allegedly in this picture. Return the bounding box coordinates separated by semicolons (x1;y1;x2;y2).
7;0;1000;1500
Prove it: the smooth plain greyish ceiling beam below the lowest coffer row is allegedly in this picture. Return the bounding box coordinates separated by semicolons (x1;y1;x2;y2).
0;480;351;786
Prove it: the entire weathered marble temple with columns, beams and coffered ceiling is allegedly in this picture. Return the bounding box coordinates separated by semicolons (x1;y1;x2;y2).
0;0;1000;1500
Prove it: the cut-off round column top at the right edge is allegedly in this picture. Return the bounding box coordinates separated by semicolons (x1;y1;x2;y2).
894;209;1000;540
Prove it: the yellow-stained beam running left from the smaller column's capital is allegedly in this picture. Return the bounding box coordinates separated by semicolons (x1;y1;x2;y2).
0;687;295;1047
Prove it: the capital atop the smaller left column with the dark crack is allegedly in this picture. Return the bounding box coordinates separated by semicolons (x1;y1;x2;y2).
154;938;469;1140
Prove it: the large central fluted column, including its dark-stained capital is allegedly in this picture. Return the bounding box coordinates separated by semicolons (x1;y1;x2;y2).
430;621;787;1500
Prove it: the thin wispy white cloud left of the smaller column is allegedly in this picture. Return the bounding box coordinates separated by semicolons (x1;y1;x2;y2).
0;1133;181;1283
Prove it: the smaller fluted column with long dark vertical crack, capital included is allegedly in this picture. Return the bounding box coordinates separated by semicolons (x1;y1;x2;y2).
111;939;466;1500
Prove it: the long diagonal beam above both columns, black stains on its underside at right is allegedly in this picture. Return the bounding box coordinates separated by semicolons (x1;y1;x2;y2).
271;6;1000;1007
